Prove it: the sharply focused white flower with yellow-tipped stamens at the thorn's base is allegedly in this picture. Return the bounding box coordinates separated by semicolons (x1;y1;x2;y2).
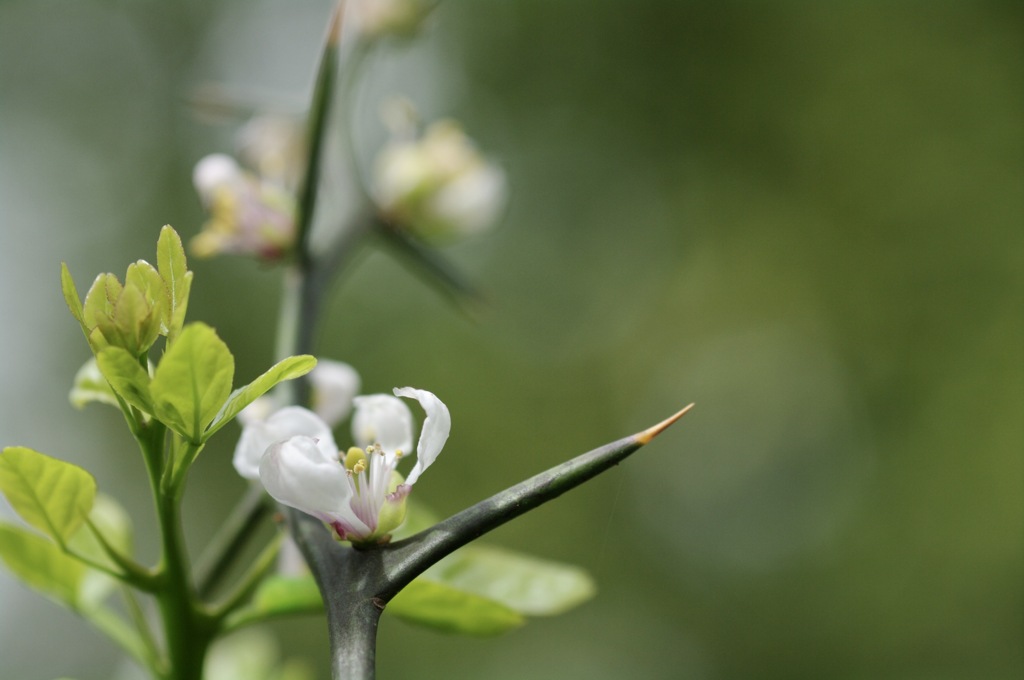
259;387;452;543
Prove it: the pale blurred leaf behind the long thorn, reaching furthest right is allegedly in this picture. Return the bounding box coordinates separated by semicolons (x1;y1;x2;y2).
424;546;596;617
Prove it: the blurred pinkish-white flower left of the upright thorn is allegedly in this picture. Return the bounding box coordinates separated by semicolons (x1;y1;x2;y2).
189;154;295;260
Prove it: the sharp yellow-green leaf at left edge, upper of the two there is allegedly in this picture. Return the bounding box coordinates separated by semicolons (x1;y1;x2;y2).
0;447;96;546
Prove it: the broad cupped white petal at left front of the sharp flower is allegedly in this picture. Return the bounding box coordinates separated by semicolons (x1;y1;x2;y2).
259;436;351;522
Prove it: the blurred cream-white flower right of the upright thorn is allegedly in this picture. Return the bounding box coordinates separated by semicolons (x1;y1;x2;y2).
374;121;506;242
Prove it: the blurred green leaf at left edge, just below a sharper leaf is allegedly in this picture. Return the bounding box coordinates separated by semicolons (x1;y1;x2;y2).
0;523;85;609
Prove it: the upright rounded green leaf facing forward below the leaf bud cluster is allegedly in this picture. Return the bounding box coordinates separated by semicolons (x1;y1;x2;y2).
150;323;234;445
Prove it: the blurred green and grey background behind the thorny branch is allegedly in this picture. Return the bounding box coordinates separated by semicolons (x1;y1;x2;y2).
0;0;1024;680
